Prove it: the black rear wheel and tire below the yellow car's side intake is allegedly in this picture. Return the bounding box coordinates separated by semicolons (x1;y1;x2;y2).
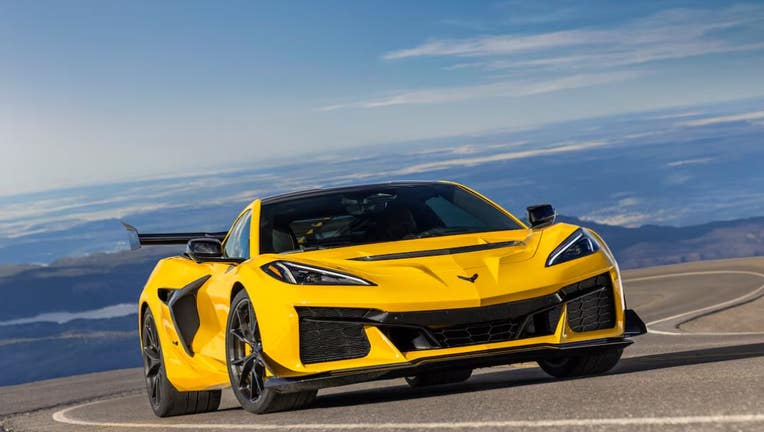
141;309;221;417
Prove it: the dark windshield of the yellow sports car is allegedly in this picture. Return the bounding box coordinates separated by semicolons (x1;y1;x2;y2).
260;183;522;253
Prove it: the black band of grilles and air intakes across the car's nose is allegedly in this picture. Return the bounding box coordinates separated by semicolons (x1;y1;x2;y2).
297;273;622;364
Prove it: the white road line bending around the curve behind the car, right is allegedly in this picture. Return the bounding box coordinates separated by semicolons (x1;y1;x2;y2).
624;270;764;336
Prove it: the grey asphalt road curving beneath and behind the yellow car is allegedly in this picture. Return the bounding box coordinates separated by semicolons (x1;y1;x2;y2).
0;259;764;432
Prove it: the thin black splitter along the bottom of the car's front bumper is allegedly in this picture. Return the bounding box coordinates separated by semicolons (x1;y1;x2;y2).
265;338;632;393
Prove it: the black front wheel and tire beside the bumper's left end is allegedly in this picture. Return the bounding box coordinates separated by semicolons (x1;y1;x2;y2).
226;290;317;414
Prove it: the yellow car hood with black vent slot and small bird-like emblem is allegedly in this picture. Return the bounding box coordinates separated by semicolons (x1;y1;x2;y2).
268;230;560;310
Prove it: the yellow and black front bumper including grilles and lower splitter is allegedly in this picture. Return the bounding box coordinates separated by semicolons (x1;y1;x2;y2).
258;270;646;392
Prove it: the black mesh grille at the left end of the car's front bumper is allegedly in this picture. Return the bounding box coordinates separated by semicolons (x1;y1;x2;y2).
297;308;371;364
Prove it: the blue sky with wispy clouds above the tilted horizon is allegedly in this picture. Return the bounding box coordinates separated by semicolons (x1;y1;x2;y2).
0;0;764;196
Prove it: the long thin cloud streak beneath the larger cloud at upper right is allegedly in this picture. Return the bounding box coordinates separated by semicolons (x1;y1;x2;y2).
318;71;641;111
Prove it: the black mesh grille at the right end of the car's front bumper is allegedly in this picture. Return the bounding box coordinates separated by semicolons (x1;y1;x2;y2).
563;275;615;332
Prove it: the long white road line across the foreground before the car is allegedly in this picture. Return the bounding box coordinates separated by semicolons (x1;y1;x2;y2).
53;399;764;431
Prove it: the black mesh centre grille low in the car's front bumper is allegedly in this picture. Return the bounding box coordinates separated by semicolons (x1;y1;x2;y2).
430;320;520;348
